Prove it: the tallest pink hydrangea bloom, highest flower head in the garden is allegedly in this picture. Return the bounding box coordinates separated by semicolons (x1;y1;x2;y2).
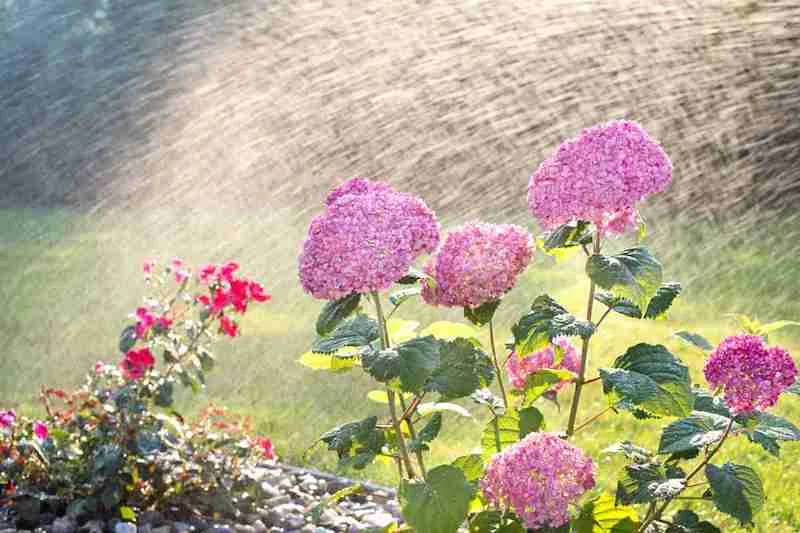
528;120;672;234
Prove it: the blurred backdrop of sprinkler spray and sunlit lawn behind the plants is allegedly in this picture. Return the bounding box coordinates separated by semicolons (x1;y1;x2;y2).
0;0;800;533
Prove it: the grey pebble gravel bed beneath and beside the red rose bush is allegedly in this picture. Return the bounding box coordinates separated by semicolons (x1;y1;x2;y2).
0;464;400;533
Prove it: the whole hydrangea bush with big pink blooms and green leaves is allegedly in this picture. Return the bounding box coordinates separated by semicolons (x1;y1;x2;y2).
300;121;800;533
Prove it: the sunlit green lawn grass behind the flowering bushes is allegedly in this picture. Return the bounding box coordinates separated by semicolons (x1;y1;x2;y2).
0;209;800;533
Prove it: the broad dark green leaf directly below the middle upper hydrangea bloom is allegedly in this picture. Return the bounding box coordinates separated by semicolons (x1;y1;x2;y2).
425;338;494;400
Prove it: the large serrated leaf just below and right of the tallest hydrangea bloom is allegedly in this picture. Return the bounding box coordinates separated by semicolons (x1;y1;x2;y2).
586;246;662;309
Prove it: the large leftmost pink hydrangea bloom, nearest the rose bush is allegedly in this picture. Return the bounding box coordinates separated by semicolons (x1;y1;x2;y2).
299;178;439;299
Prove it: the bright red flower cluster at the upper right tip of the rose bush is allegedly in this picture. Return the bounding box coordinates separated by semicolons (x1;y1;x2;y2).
197;261;272;337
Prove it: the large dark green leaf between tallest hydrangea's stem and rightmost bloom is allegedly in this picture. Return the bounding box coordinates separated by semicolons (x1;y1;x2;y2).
600;343;694;417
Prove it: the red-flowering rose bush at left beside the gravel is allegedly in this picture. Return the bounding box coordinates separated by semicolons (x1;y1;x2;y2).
0;259;275;527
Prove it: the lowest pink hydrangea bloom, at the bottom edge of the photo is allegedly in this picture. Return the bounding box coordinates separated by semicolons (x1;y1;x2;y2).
481;433;595;529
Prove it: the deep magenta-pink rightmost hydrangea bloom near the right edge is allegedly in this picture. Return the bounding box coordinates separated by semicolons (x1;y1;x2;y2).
703;335;797;413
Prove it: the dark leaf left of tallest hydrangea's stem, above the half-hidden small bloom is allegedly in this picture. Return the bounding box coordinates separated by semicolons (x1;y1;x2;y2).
511;294;594;357
